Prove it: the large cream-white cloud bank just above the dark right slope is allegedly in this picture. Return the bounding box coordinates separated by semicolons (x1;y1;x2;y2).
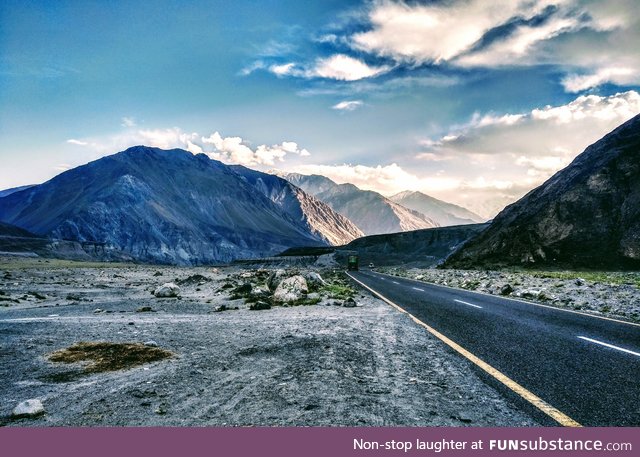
416;91;640;216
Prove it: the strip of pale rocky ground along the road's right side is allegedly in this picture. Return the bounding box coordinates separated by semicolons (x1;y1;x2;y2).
379;267;640;322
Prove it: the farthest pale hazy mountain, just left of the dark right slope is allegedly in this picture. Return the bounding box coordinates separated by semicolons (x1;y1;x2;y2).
389;190;485;227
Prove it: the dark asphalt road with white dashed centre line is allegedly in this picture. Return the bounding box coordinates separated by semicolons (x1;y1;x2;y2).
349;270;640;426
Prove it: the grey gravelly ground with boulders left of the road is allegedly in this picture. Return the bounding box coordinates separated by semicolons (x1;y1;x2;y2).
0;257;536;426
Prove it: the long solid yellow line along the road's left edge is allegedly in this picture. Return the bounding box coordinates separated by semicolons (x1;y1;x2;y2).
346;272;582;427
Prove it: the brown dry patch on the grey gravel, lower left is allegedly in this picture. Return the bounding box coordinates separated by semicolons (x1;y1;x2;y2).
49;342;175;373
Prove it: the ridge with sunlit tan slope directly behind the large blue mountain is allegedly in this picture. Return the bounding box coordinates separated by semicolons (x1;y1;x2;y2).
231;165;364;246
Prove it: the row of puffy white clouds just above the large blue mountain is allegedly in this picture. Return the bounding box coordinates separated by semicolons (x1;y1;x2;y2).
67;127;311;166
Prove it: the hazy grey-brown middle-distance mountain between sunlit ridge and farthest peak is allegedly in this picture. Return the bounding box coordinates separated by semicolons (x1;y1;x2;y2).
281;173;438;235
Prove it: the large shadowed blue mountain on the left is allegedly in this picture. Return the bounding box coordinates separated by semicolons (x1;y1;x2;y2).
0;146;360;265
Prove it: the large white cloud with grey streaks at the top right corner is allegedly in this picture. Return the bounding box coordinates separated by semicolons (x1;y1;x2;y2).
342;0;640;93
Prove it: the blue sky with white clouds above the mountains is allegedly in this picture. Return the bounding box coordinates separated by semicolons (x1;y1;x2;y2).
0;0;640;217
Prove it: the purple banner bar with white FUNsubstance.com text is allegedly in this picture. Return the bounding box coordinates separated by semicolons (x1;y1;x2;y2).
0;427;640;457
